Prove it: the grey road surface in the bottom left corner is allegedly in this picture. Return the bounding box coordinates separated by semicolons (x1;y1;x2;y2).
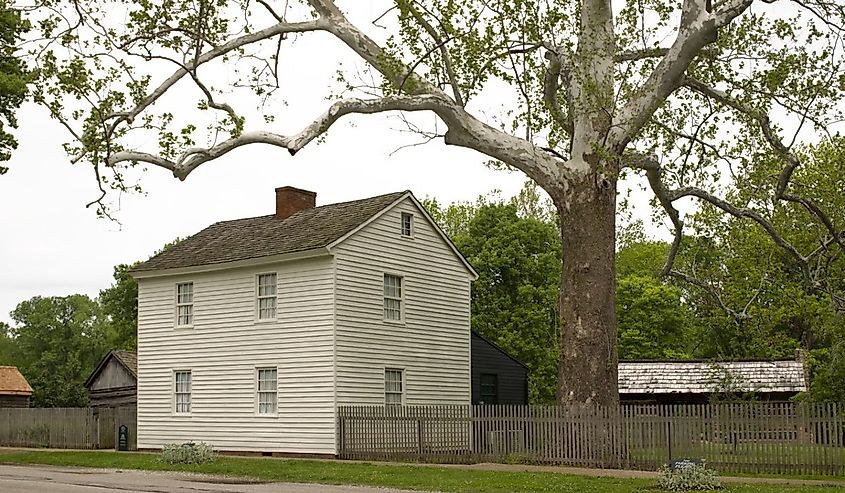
0;465;436;493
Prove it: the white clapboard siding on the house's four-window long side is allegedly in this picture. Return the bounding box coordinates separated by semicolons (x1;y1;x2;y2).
138;257;335;454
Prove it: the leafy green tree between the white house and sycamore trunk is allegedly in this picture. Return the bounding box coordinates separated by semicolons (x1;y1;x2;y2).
454;201;560;403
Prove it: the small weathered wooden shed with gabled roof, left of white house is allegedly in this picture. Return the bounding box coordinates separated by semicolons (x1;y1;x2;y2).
85;351;138;407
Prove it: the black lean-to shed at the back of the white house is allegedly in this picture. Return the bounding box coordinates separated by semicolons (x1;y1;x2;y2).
471;332;528;404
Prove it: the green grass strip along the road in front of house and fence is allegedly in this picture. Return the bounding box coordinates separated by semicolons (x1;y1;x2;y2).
0;450;845;493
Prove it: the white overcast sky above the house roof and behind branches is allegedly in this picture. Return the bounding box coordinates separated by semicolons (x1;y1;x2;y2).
0;2;680;322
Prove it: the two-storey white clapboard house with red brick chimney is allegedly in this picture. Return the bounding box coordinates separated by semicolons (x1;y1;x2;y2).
133;187;477;455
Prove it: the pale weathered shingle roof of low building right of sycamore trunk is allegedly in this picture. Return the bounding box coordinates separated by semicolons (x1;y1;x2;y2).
619;360;807;394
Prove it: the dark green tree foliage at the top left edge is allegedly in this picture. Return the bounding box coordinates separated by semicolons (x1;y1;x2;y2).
0;0;31;171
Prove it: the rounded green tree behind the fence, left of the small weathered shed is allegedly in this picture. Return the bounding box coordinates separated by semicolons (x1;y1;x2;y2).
11;294;110;407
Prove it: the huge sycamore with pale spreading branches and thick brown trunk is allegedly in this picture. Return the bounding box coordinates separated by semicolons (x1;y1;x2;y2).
23;0;845;404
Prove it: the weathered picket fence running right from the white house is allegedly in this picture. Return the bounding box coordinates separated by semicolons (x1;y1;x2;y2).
337;403;845;475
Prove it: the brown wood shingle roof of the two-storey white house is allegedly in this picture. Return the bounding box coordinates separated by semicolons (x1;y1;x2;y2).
132;191;410;272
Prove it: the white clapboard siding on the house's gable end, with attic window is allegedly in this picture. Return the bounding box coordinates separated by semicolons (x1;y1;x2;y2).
333;198;471;405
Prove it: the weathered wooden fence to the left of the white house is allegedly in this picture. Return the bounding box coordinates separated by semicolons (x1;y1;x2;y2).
0;407;137;450
